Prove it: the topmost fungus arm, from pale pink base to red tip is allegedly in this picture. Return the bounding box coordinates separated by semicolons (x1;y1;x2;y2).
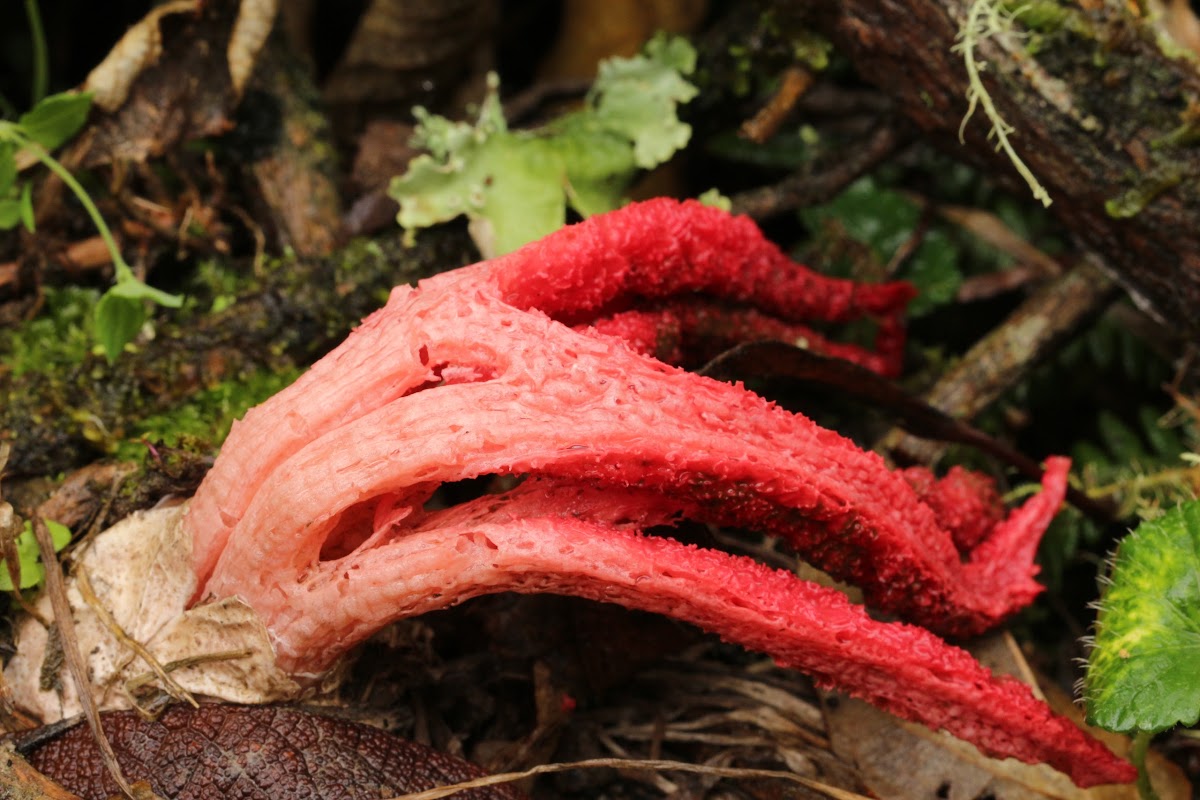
190;199;913;584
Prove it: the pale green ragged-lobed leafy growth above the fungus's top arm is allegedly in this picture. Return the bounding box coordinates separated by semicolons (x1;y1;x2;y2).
389;35;697;257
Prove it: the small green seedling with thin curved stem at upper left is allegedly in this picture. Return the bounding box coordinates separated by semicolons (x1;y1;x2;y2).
0;92;182;361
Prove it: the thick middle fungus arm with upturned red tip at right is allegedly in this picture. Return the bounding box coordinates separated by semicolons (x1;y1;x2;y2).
204;289;1067;634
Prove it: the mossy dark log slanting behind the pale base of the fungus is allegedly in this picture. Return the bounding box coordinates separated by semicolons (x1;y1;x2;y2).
0;229;474;475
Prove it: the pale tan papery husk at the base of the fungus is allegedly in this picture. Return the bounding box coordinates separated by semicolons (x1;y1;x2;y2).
5;505;301;722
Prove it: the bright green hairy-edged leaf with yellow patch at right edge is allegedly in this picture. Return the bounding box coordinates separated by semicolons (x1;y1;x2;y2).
1084;500;1200;732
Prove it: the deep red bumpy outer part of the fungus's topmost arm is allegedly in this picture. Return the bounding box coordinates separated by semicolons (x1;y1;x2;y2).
451;198;914;323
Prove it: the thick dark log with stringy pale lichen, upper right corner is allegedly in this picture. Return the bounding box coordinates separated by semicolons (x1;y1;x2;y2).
796;0;1200;336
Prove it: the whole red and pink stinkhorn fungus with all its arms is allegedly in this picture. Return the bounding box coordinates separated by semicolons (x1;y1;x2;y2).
188;200;1134;786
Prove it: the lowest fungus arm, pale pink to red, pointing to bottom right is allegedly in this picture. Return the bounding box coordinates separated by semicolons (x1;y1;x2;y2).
248;486;1134;786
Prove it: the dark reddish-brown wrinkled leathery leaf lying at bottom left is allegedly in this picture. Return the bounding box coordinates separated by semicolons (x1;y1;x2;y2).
18;704;522;800
